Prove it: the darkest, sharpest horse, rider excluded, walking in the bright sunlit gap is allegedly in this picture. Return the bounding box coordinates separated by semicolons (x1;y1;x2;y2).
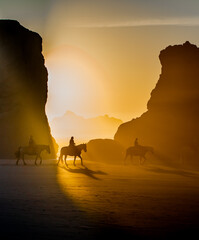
57;144;87;166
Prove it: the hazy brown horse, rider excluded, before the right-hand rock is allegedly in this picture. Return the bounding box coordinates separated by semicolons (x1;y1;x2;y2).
124;145;153;165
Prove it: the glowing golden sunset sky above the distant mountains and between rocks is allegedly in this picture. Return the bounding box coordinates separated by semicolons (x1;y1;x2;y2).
0;0;199;121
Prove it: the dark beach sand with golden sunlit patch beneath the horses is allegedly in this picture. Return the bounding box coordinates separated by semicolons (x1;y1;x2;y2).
0;160;199;239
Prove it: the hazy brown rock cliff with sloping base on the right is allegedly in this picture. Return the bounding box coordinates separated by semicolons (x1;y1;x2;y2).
115;42;199;166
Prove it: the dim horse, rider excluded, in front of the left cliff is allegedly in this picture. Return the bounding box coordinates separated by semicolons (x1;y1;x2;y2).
15;145;50;165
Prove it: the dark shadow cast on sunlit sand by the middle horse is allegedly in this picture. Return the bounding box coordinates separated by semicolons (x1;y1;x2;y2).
60;166;107;180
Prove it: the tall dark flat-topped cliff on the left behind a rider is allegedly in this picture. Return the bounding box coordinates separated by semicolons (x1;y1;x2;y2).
0;20;54;158
